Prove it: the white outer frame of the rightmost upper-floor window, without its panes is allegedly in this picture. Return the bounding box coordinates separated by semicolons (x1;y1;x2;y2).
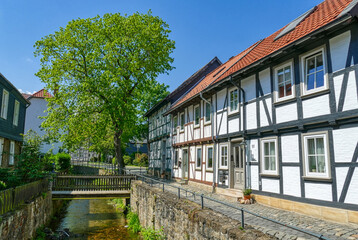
301;47;329;96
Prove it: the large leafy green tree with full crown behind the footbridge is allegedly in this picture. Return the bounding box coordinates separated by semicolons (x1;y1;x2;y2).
35;12;174;172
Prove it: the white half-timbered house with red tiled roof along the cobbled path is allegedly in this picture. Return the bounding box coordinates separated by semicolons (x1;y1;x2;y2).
166;0;358;221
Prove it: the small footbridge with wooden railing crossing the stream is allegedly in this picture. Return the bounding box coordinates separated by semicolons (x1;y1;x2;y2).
52;175;136;199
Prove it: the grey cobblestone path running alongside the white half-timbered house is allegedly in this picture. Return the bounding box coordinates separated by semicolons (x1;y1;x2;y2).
139;176;358;240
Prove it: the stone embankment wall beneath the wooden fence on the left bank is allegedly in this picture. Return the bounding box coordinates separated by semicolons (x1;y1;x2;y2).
0;192;53;239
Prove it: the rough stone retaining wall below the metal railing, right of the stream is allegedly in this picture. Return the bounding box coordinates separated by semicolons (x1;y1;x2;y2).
131;181;273;240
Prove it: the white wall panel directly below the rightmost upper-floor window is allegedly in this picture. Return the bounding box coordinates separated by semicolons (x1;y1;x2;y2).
302;94;330;118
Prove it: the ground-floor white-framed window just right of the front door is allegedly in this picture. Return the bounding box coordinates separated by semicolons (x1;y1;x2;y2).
261;138;278;174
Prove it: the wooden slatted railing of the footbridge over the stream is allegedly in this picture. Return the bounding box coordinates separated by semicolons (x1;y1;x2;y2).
52;175;135;191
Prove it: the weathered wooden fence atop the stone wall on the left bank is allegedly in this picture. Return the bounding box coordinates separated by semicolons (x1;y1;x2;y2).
0;179;49;215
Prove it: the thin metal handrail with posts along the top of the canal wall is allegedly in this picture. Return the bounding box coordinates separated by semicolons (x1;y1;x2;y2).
127;170;329;240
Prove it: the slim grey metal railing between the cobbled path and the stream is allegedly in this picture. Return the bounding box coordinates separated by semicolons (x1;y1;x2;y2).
127;171;329;240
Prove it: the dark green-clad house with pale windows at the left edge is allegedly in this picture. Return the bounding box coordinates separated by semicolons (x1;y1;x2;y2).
0;74;30;167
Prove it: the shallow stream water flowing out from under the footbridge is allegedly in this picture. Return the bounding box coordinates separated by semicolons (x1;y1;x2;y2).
58;200;140;240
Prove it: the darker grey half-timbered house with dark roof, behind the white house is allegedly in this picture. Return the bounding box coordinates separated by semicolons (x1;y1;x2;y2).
145;57;221;177
